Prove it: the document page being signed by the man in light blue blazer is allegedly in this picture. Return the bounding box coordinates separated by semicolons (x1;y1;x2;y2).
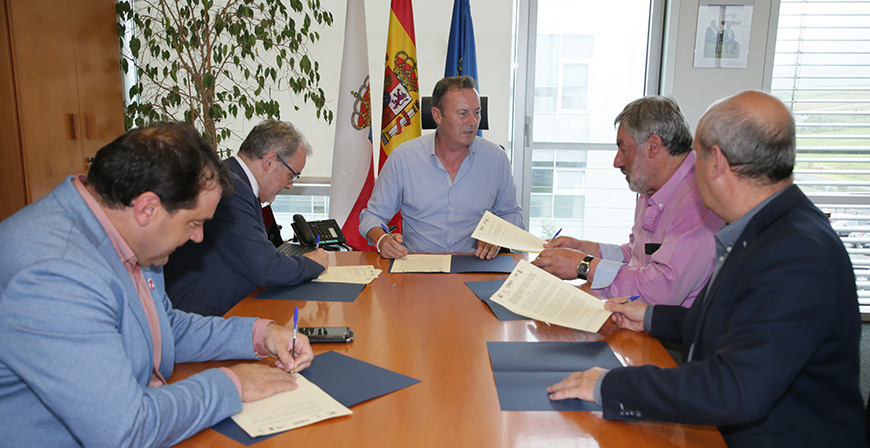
233;374;353;437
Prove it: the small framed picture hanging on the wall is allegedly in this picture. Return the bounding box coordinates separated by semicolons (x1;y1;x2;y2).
694;0;753;68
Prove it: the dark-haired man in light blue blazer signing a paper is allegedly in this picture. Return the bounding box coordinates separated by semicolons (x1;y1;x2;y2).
0;124;314;447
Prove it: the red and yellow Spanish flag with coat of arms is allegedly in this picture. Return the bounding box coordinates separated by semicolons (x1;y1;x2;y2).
378;0;421;168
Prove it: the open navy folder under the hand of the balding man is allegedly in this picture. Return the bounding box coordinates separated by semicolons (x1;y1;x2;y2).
486;342;622;411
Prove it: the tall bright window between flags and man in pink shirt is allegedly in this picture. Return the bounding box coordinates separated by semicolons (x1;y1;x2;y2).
512;0;661;243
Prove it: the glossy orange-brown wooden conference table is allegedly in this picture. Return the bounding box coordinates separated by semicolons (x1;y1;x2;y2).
172;252;725;448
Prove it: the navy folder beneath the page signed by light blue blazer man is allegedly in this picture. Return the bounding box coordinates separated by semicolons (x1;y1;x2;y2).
212;351;420;446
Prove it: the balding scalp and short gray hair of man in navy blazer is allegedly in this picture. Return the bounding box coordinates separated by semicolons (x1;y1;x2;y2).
695;91;795;184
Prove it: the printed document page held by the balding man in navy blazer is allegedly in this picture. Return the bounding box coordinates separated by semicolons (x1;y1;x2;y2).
490;260;611;333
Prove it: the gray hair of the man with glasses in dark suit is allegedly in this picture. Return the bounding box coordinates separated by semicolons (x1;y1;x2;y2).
239;120;312;160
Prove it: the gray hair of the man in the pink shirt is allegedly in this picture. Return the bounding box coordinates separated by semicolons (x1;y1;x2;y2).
613;96;692;156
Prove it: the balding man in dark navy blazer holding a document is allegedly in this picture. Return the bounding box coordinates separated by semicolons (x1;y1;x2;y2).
548;92;867;447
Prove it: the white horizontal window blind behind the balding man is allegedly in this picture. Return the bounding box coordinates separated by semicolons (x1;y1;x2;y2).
771;0;870;320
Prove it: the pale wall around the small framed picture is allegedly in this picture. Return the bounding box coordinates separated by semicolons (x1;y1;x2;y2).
661;0;779;130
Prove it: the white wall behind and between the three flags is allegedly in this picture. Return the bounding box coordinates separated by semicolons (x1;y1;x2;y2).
226;0;512;177
